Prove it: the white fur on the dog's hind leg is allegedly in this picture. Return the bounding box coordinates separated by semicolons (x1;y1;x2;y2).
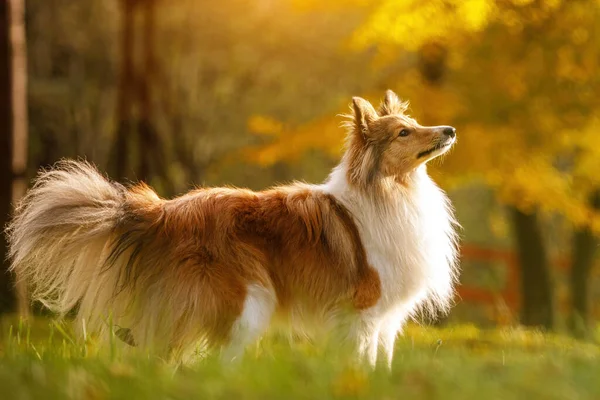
221;284;276;363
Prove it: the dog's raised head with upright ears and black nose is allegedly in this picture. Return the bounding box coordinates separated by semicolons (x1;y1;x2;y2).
348;90;456;183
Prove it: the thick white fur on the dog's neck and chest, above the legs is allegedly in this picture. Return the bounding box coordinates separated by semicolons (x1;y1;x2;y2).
321;166;456;313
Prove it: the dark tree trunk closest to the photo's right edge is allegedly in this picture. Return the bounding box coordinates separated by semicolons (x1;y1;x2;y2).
570;190;600;337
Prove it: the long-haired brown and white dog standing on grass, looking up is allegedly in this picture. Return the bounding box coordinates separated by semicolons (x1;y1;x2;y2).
7;91;457;365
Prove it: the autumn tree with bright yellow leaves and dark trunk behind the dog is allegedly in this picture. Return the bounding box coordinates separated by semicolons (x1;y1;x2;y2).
248;0;600;328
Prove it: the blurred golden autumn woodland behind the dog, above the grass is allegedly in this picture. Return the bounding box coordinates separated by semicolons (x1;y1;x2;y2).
0;0;600;337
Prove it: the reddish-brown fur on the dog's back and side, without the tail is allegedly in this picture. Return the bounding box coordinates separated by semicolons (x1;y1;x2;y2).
113;184;380;344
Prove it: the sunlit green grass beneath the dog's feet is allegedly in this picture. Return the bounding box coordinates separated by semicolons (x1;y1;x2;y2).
0;320;600;400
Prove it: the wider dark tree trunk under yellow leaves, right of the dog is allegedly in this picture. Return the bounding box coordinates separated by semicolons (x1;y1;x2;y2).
511;208;554;330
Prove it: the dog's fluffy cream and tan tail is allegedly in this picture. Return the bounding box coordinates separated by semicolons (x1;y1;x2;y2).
6;161;160;338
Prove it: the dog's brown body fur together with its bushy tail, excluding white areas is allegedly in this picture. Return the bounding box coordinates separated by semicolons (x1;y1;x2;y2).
8;161;380;357
